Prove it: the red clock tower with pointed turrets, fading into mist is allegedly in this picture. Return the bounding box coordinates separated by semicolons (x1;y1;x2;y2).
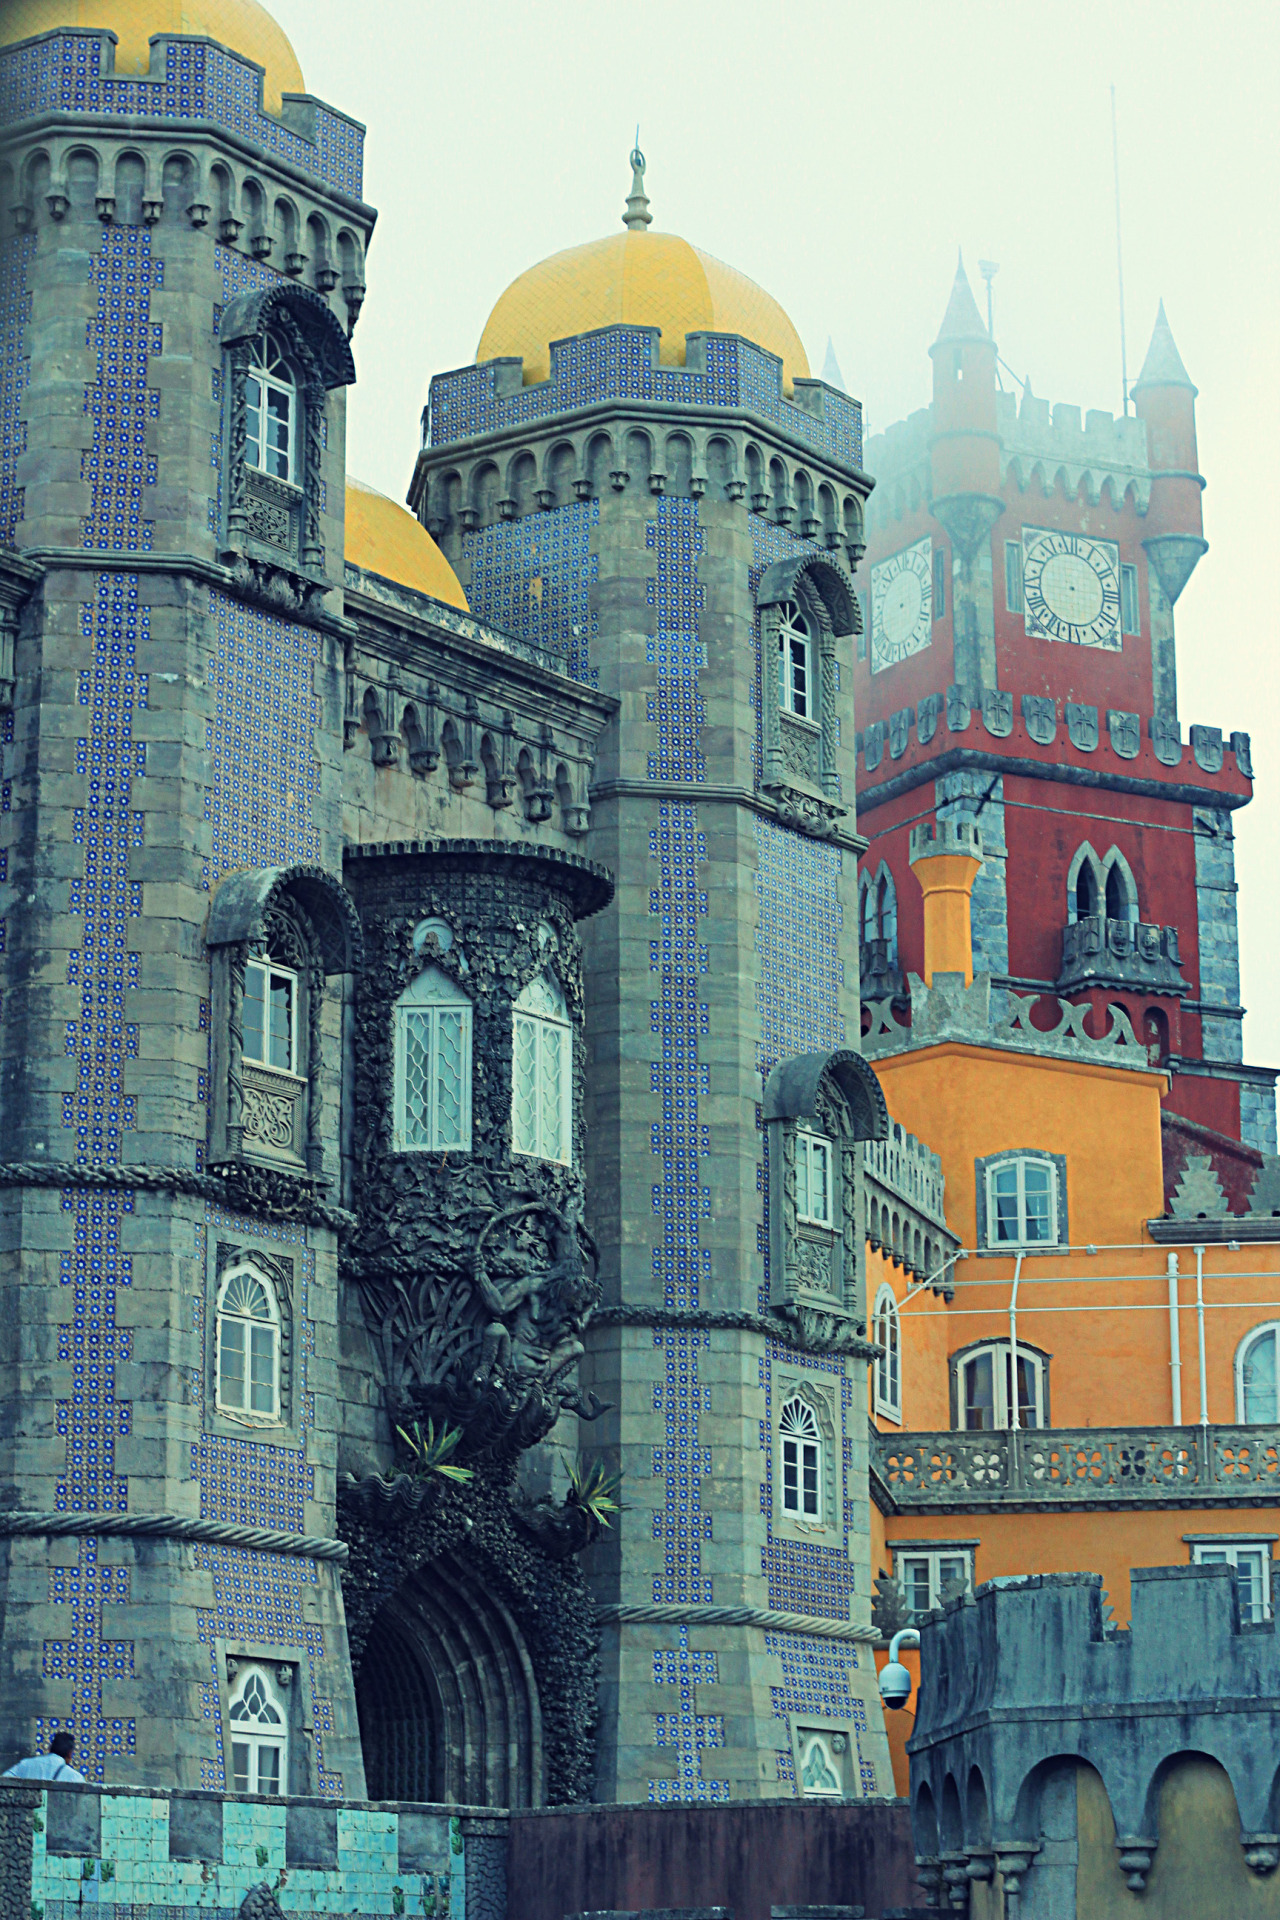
856;265;1276;1181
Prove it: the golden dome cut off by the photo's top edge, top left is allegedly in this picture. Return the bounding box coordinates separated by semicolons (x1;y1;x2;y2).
0;0;307;113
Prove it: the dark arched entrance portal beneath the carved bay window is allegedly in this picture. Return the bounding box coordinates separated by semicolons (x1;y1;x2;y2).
355;1559;543;1807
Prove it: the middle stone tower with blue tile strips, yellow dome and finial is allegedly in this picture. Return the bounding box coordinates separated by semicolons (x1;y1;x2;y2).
411;154;890;1801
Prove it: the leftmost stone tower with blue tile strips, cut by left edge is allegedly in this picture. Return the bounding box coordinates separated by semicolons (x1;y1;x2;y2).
0;0;372;1795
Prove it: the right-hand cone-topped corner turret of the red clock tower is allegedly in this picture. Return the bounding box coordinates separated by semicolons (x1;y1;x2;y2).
1132;300;1205;609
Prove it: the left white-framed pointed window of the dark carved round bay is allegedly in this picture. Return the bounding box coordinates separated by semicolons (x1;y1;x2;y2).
393;966;472;1154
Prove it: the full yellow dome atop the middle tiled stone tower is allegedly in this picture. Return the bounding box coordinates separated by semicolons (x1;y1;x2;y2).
476;228;810;392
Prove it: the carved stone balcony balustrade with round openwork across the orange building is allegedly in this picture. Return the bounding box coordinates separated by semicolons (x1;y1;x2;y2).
871;1427;1280;1513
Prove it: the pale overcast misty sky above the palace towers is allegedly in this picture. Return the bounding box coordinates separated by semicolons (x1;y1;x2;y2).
269;0;1280;1066
